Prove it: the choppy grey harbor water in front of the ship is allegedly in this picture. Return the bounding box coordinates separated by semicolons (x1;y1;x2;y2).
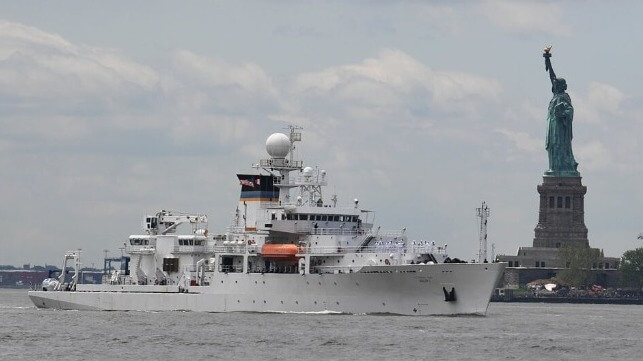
0;289;643;361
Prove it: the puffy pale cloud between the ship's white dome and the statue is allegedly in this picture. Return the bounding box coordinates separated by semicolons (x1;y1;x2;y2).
291;49;502;122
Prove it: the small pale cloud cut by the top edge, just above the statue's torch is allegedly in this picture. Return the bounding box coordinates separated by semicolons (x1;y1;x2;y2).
477;0;572;36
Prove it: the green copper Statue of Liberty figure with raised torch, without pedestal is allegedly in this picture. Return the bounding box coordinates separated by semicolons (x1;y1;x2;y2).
543;46;580;177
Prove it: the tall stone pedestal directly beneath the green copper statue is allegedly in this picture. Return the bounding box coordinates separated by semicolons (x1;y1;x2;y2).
534;175;589;248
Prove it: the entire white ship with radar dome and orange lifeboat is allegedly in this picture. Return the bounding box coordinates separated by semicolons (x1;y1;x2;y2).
29;127;505;315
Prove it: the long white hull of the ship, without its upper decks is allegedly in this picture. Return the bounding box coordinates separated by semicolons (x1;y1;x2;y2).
29;263;505;315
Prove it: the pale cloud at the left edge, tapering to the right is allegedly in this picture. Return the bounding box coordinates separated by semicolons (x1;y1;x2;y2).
0;20;160;100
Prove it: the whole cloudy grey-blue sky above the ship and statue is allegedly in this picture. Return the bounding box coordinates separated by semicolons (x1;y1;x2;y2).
0;0;643;267
